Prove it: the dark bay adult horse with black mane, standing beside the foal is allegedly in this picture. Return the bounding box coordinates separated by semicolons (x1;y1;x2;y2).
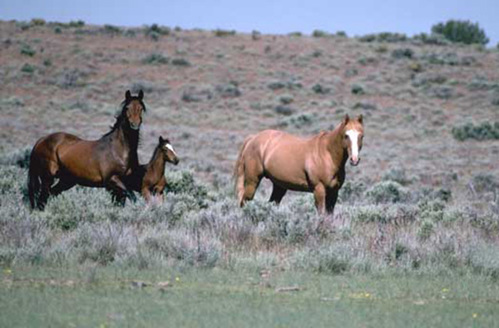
28;90;146;210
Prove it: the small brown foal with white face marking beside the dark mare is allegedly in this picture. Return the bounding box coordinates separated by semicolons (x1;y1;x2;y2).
123;136;179;202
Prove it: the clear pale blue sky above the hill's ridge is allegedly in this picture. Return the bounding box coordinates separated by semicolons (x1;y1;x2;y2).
0;0;499;46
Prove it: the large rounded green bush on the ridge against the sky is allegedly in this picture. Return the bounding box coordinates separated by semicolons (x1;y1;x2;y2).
431;20;489;45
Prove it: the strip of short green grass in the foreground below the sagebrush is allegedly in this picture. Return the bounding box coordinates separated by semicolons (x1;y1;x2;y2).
0;267;499;327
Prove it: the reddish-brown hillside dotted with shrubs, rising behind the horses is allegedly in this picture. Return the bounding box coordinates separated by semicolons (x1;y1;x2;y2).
0;22;499;192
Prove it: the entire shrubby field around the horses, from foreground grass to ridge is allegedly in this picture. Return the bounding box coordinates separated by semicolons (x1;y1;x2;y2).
0;21;499;327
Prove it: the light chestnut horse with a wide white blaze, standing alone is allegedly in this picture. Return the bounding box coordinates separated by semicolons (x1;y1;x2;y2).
234;115;364;214
